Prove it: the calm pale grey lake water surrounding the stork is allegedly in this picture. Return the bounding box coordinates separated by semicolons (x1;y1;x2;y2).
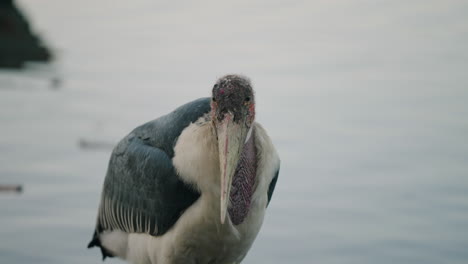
0;0;468;264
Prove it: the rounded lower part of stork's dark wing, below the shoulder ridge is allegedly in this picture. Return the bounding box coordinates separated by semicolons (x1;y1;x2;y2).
97;138;199;235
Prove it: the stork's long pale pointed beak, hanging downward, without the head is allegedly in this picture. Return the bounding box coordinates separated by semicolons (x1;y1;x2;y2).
216;113;248;224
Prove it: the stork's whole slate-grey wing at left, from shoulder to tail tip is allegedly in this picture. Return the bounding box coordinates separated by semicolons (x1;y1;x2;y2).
88;98;210;248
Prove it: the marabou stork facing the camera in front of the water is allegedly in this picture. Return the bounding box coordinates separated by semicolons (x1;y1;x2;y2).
88;75;280;264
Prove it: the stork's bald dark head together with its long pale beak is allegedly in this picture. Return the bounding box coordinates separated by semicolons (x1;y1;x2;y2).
211;75;255;223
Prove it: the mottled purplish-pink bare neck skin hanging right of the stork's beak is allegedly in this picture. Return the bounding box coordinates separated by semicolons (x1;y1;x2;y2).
228;127;257;225
